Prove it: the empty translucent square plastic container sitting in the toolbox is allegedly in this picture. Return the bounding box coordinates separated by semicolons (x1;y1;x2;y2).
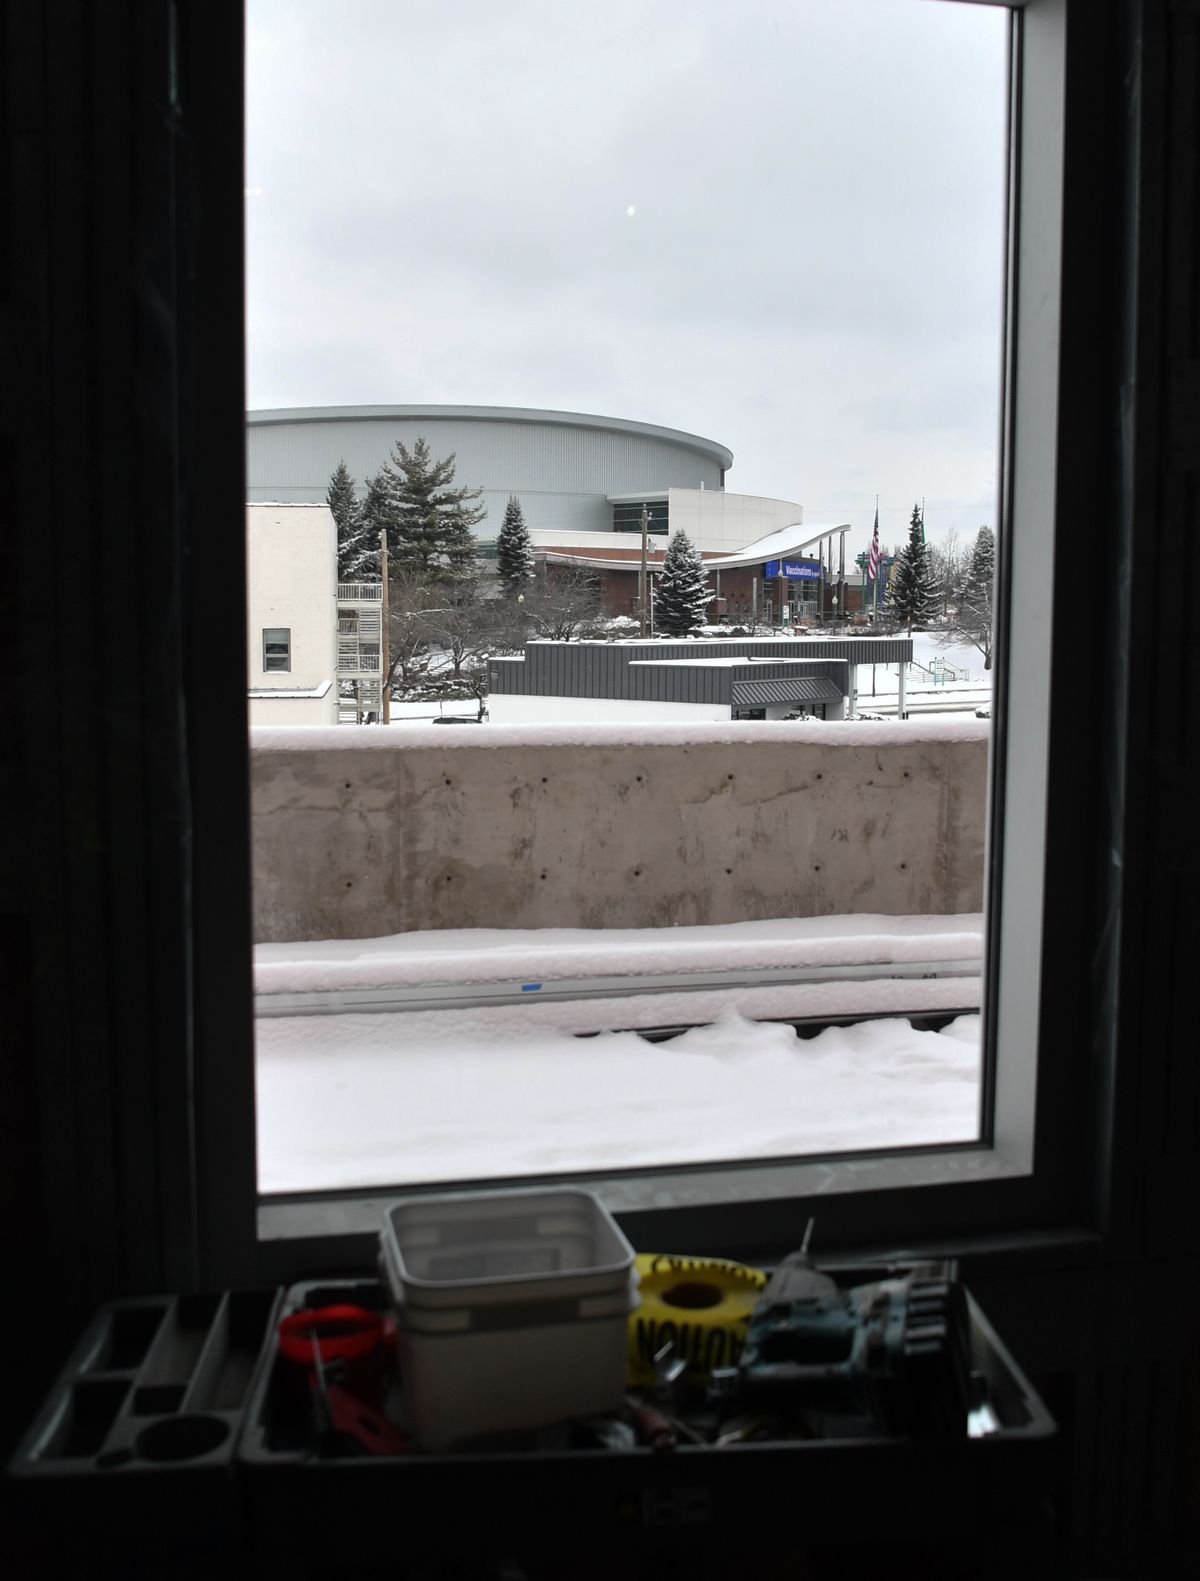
379;1187;648;1450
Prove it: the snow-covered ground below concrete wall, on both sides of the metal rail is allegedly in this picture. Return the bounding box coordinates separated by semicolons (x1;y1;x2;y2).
256;917;982;1192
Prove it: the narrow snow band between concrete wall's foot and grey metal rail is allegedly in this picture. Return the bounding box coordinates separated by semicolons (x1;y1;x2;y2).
255;912;983;994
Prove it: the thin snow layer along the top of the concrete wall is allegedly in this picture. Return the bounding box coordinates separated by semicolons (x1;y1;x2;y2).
250;718;991;753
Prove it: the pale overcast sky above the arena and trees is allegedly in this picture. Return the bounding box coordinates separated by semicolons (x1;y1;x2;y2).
247;0;1007;549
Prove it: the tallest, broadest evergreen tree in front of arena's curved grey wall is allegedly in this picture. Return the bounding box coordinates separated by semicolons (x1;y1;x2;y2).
379;436;487;582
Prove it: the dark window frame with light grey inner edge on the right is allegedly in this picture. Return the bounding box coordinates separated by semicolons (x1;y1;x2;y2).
185;0;1137;1284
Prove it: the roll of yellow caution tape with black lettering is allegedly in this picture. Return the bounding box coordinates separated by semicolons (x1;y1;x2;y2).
629;1252;767;1387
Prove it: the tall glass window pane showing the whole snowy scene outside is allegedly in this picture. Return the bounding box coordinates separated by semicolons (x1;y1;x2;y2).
247;0;1007;1190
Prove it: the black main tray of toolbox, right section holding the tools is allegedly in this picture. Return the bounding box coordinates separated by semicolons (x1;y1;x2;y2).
237;1265;1055;1559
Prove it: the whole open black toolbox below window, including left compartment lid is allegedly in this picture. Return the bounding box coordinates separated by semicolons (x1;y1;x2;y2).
9;1265;1055;1575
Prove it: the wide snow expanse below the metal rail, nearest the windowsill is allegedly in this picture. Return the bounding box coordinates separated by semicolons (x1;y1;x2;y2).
258;1002;980;1192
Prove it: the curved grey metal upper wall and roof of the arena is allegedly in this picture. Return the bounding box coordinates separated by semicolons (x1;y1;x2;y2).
247;406;734;539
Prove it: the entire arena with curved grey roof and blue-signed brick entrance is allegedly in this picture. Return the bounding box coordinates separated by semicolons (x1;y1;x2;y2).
247;406;846;620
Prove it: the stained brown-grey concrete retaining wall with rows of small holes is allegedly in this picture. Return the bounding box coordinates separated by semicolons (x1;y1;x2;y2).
253;726;987;941
